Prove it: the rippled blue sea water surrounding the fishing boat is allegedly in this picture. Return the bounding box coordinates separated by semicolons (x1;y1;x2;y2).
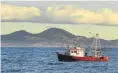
1;47;118;73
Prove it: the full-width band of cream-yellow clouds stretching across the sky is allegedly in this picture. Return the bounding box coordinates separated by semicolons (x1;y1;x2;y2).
1;4;118;25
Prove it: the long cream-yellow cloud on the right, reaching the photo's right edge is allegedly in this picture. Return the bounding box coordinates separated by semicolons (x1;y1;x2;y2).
47;5;118;25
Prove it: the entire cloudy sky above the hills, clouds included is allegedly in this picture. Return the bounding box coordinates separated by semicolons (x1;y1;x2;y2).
1;1;118;40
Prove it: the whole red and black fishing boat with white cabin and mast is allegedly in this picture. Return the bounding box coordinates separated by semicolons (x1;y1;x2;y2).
56;34;108;62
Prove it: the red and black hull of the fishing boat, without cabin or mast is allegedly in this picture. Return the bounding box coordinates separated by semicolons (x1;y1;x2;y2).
57;53;108;62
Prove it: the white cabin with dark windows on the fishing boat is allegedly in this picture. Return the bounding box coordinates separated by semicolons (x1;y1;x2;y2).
67;47;84;57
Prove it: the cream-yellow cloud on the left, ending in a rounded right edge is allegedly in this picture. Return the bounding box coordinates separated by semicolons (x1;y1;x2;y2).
1;4;41;20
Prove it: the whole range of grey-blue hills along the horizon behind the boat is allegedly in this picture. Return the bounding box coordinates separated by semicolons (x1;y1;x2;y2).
1;28;118;46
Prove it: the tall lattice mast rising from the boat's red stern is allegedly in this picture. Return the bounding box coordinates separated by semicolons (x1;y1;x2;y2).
91;34;101;57
